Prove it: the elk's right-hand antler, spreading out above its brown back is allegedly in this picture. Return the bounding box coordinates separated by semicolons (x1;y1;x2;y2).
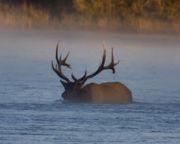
72;48;120;83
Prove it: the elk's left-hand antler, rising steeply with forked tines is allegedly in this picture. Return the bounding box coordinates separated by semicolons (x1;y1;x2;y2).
52;43;71;82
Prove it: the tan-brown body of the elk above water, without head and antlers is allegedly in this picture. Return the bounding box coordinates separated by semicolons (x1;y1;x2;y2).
80;82;132;103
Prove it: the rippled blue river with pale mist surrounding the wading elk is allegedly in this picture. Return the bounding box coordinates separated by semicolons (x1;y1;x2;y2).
0;28;180;144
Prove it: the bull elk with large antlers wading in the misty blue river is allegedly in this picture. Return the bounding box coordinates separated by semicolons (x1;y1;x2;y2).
52;44;132;103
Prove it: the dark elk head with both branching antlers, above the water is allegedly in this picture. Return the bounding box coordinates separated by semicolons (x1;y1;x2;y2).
52;44;119;99
